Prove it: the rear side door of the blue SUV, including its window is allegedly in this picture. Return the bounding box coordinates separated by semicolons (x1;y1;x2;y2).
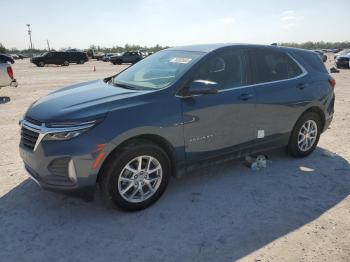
250;48;309;142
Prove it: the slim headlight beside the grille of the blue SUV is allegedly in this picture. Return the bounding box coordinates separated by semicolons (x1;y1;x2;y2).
43;120;101;140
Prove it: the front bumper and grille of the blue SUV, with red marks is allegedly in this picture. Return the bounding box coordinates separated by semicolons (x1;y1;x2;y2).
19;118;114;199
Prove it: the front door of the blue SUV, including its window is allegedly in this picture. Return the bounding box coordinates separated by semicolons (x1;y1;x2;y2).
182;49;256;161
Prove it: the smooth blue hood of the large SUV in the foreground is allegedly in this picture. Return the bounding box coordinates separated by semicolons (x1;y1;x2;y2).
26;80;149;123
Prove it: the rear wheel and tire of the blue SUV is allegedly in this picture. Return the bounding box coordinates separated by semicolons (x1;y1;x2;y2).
288;112;322;157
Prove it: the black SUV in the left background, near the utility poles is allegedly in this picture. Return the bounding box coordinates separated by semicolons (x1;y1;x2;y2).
30;51;88;67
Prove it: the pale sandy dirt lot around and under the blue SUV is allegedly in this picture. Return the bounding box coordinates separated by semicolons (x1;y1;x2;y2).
0;57;350;262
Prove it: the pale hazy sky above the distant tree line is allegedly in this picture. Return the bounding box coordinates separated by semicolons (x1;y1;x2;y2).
0;0;350;49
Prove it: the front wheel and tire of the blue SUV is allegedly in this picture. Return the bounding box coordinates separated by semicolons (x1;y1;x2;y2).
99;141;171;211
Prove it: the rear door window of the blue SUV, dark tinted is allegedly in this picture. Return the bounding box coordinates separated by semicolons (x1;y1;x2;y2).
252;50;302;83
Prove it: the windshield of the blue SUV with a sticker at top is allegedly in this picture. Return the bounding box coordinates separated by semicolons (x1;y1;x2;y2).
111;50;204;90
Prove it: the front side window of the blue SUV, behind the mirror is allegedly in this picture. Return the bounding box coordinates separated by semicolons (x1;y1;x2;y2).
193;51;247;90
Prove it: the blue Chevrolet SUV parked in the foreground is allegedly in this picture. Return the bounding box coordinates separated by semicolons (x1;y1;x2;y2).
19;44;335;210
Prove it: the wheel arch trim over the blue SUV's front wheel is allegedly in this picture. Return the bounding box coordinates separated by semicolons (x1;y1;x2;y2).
96;134;177;182
